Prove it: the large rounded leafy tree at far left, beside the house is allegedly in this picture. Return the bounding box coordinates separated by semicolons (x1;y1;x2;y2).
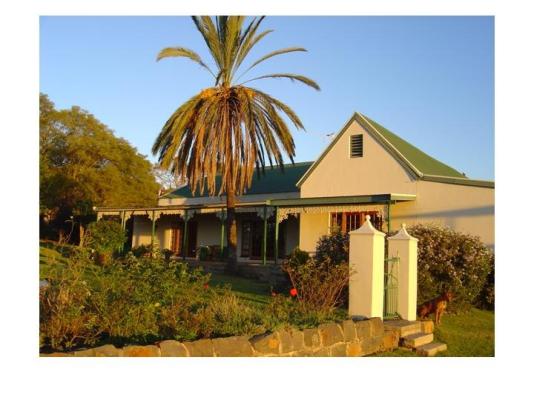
39;94;158;242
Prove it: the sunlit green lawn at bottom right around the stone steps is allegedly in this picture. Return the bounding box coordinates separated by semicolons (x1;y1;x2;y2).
377;308;495;357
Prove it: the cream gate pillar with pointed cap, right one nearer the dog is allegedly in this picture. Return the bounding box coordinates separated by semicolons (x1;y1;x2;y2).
388;224;419;321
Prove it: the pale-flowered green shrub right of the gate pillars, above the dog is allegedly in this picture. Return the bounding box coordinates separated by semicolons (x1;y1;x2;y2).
408;225;492;311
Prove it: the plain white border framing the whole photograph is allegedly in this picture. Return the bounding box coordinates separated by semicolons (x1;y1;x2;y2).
0;0;534;400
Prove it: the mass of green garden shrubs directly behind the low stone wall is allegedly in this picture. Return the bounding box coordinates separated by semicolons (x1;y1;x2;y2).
40;251;343;351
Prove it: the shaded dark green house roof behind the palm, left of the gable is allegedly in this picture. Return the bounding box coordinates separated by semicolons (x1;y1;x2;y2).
161;161;313;199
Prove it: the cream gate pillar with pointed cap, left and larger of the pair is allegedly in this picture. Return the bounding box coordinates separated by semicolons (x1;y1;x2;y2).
349;215;385;318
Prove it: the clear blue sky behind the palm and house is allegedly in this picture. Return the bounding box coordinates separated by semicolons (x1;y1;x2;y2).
40;17;494;179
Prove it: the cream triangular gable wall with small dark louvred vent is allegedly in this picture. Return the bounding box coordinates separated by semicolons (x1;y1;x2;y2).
300;121;416;197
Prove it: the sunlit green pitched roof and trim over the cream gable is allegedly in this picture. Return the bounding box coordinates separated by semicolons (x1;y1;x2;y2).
297;112;495;187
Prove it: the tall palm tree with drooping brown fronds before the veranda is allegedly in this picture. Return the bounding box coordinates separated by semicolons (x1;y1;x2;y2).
152;16;319;272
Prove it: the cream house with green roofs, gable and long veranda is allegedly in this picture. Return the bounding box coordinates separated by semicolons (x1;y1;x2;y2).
97;113;495;263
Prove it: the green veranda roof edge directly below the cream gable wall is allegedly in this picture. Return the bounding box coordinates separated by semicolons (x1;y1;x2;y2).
267;193;415;207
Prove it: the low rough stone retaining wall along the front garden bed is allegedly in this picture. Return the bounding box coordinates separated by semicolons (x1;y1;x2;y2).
42;318;399;357
